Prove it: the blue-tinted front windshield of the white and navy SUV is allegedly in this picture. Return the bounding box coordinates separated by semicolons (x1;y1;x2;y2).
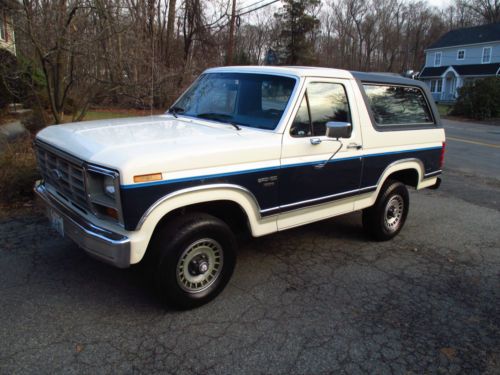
169;73;296;130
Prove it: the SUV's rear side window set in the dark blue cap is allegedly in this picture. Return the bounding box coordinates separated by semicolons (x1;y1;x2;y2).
363;84;434;127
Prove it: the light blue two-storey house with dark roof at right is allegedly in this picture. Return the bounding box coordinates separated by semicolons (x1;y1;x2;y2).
419;23;500;102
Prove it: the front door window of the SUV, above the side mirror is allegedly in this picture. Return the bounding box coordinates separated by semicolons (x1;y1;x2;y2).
290;82;351;137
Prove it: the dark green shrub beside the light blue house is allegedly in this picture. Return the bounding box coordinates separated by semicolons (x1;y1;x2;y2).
451;77;500;120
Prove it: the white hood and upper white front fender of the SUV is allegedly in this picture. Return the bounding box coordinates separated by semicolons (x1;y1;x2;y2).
37;115;281;184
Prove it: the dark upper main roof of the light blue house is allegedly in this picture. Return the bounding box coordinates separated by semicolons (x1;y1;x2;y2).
427;22;500;49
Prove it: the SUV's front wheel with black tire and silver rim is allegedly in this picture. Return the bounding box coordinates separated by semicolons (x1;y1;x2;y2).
148;213;236;310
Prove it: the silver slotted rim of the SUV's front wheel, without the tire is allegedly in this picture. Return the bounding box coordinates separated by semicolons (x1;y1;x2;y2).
177;238;224;293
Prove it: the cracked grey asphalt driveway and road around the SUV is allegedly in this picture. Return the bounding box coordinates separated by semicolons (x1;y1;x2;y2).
0;122;500;374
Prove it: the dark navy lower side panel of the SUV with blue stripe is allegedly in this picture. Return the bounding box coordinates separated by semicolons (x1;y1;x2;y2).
120;147;441;230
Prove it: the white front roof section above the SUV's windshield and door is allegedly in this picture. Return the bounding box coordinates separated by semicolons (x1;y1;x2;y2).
205;65;353;79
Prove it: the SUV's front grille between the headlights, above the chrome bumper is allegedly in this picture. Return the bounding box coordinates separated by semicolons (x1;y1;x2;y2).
36;144;88;210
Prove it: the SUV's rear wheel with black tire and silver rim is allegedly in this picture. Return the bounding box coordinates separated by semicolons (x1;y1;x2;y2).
363;180;410;241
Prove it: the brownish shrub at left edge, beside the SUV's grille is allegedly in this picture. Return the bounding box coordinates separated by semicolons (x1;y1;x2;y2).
0;136;39;205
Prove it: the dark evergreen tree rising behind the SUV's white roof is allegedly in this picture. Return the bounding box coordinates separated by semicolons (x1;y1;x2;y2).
275;0;320;65
